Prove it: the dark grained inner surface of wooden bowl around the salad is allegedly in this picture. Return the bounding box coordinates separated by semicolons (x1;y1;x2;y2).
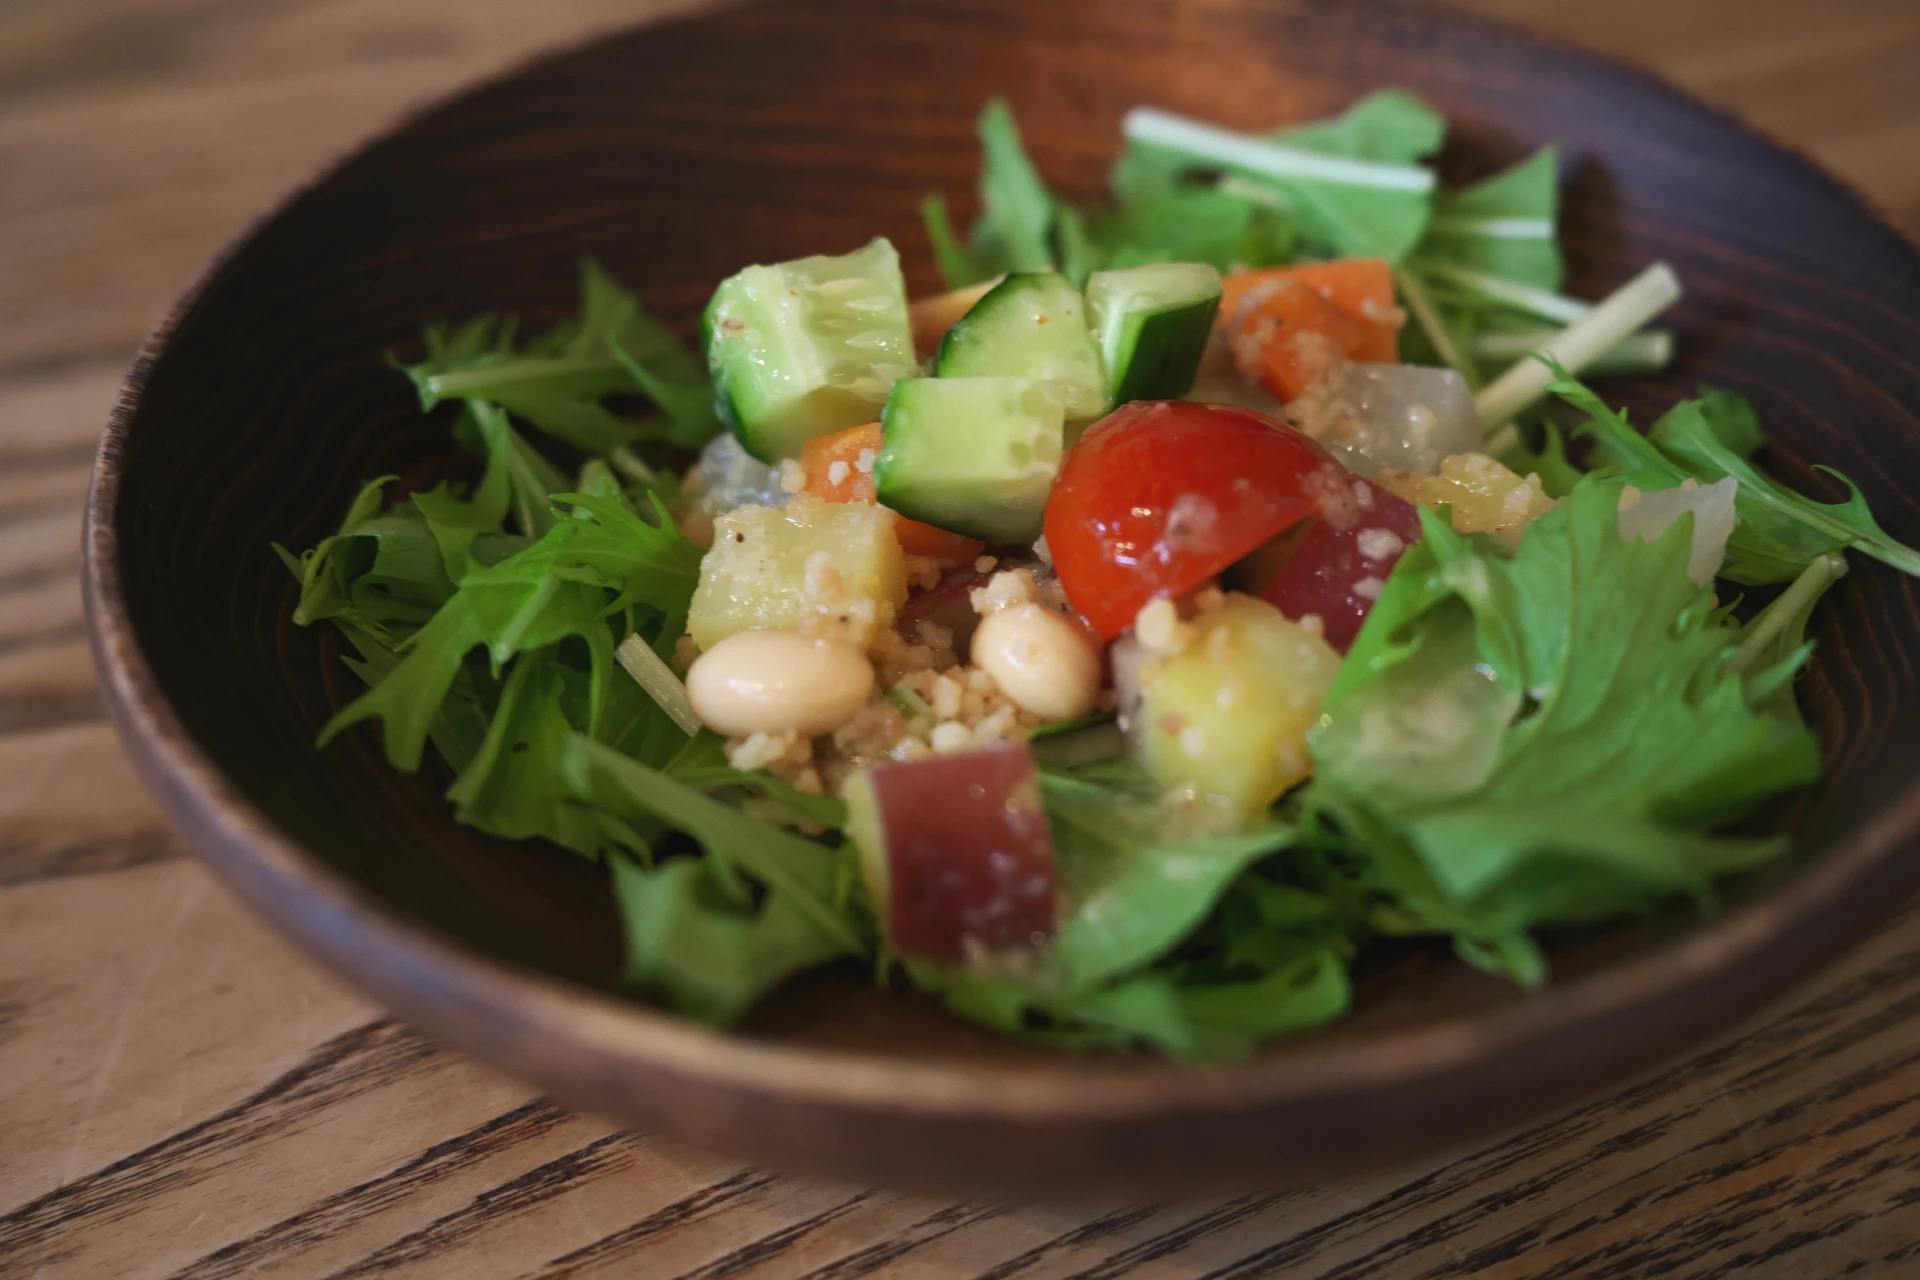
101;0;1920;1071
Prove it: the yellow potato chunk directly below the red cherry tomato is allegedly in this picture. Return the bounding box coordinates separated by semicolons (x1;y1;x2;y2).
1135;595;1340;816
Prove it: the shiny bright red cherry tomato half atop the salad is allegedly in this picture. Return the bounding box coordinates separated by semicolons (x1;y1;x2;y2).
1046;399;1350;639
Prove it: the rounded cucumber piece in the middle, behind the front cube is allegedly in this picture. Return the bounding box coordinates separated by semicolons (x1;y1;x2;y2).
933;271;1108;420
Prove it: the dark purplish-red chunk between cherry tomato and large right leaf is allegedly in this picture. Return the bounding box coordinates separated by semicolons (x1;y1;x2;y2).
1260;476;1421;652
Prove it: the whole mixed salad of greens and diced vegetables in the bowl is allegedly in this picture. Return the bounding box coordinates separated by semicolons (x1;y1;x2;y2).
276;92;1920;1059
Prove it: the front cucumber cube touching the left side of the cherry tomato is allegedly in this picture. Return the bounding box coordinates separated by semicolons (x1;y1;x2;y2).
874;378;1066;543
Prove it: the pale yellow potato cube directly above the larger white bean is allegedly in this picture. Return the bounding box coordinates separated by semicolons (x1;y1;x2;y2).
687;493;906;649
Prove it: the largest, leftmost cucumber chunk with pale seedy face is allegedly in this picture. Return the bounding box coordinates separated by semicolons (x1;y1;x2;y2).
701;238;920;462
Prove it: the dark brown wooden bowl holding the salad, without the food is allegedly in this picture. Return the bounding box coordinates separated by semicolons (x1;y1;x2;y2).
74;0;1920;1196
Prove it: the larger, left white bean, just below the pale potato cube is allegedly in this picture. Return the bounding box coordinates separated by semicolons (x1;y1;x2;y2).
687;631;874;737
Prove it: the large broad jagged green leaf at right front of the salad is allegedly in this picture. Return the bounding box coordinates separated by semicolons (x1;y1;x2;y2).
1308;478;1818;981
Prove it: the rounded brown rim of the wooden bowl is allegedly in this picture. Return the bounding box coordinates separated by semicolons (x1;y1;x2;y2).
81;2;1920;1143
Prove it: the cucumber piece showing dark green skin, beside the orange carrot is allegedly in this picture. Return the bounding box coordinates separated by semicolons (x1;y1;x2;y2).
1087;263;1219;405
